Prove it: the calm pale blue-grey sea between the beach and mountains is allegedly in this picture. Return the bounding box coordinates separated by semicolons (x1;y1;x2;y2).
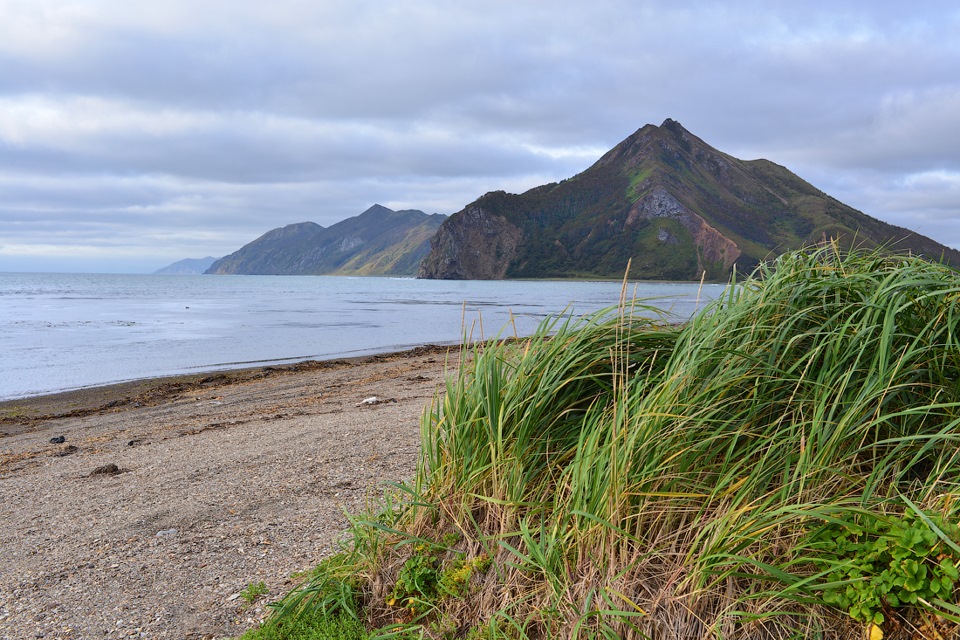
0;273;723;399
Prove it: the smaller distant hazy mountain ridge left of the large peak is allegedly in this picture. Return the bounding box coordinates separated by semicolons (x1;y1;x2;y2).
207;204;446;275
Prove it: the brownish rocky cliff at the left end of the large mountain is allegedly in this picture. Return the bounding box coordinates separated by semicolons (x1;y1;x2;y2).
418;204;523;280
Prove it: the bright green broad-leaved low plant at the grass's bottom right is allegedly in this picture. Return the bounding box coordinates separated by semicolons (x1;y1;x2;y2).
814;511;960;625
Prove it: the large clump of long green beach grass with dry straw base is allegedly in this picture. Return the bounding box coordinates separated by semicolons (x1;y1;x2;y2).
264;246;960;639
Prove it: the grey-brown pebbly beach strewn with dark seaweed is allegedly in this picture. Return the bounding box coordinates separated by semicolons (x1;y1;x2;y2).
0;346;458;639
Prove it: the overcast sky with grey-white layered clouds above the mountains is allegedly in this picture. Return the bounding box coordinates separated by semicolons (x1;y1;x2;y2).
0;0;960;272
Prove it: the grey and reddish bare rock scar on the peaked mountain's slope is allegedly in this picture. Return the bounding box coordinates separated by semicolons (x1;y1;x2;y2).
626;187;740;273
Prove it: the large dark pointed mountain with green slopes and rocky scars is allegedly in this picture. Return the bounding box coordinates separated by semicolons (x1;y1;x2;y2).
419;119;960;280
